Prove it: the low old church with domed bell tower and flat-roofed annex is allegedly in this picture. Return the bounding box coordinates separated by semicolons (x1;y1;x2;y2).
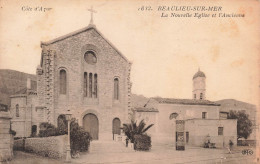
134;69;237;148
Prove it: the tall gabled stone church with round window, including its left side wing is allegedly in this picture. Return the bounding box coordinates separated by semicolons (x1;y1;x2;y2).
11;19;131;140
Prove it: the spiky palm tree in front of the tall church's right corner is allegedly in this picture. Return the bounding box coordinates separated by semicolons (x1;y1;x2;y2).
123;120;154;143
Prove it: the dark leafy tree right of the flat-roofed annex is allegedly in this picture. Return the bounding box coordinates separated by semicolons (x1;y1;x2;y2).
228;110;252;139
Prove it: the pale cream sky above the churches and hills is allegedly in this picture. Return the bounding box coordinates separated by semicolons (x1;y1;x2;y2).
0;0;260;104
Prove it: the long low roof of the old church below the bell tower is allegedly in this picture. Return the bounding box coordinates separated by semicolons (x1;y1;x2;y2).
153;97;220;106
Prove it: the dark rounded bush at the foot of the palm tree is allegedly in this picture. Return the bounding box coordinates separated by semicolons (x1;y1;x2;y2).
134;134;152;151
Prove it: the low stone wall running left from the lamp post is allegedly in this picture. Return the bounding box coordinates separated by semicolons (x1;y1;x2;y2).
14;135;68;158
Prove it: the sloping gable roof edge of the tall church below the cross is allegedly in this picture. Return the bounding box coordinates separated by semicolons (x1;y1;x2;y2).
41;24;131;64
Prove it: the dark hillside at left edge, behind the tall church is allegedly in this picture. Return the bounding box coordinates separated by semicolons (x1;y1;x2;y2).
0;69;36;106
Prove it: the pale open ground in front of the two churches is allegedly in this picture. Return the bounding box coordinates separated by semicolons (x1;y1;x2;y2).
6;141;255;164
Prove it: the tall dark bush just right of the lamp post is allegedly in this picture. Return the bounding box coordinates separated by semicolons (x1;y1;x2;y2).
70;119;92;155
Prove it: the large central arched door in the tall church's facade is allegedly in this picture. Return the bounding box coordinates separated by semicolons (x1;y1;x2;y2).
83;113;99;140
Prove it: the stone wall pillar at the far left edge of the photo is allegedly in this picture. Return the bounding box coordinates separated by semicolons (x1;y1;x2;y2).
0;112;13;162
